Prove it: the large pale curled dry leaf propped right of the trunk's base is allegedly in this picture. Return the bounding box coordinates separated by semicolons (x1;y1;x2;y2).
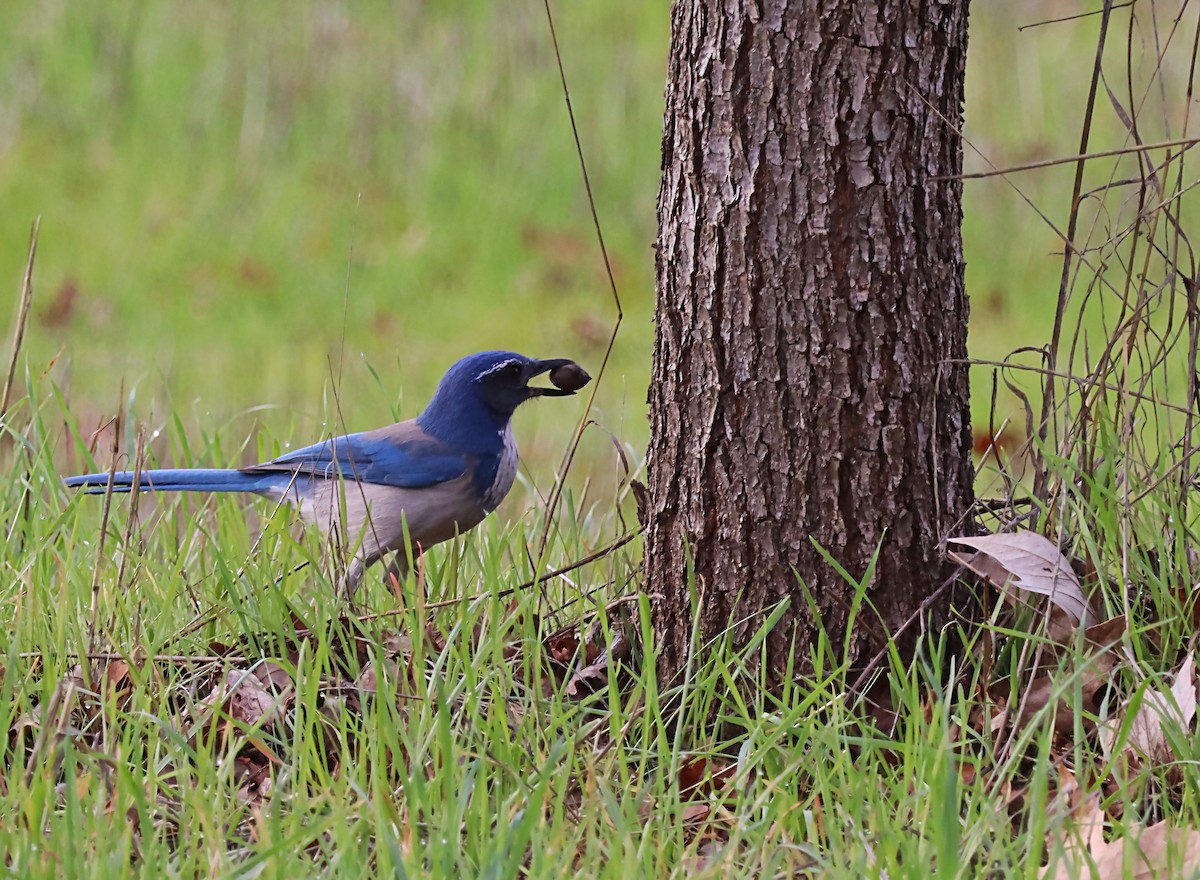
948;532;1088;624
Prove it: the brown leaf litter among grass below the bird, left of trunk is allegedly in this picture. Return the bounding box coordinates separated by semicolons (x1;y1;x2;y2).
10;600;635;845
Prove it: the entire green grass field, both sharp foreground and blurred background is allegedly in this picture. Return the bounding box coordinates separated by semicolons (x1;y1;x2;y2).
0;0;1200;880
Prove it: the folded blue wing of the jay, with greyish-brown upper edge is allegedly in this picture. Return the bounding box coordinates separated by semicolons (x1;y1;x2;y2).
244;421;467;489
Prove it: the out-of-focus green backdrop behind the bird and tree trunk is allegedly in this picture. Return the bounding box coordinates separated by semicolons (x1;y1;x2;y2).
0;0;1180;487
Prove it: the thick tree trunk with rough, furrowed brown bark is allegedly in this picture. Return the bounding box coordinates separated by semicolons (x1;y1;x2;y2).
646;0;972;681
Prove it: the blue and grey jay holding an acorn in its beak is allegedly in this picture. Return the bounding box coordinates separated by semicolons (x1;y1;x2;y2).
64;352;590;592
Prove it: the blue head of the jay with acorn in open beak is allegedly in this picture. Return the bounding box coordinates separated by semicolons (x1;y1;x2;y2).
418;352;592;442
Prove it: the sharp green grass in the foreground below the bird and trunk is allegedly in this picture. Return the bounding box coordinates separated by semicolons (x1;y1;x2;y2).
0;383;1200;878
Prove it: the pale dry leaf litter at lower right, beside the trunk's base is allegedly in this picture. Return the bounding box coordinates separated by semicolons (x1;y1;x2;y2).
947;532;1200;880
